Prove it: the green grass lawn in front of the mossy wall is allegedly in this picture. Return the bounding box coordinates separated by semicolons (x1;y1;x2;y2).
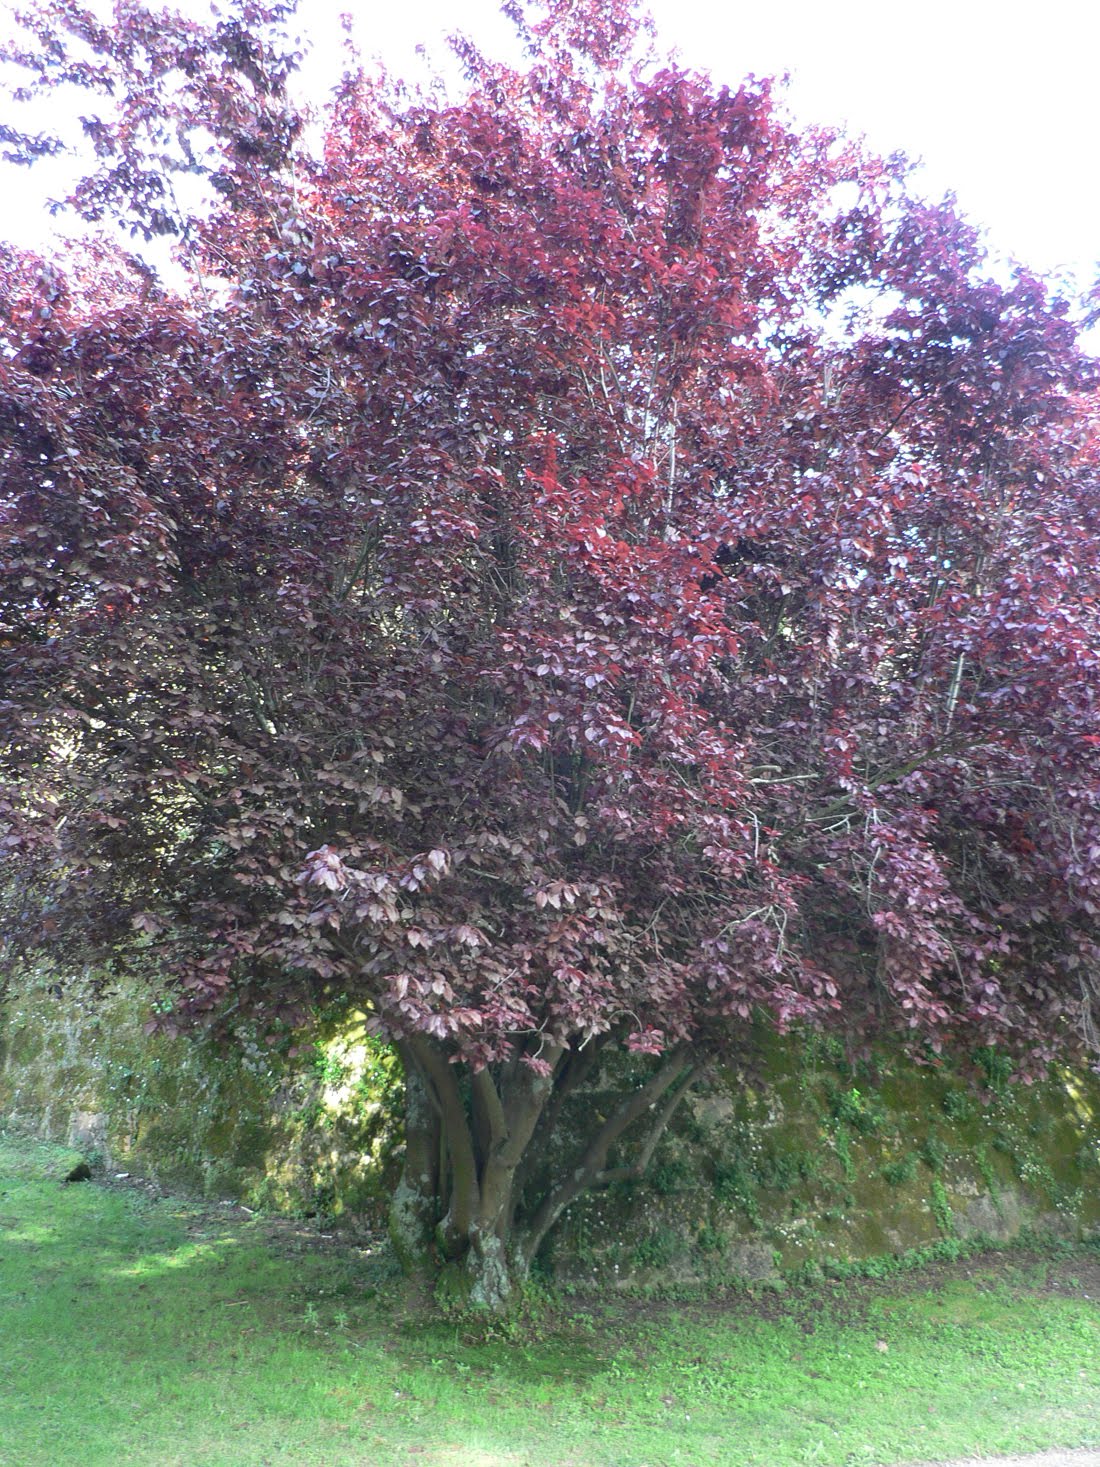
0;1137;1100;1467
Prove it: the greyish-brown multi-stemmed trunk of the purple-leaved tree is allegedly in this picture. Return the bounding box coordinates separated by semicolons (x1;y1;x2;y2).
390;1037;692;1311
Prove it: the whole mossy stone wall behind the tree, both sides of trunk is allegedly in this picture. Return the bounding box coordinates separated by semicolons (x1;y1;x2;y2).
0;977;1100;1287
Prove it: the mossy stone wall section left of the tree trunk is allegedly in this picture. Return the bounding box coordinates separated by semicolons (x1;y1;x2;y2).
0;974;400;1219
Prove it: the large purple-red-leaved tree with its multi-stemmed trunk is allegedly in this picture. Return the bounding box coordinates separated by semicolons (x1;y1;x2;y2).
0;0;1100;1306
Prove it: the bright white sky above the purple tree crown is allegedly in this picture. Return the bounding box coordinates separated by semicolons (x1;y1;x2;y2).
0;0;1100;297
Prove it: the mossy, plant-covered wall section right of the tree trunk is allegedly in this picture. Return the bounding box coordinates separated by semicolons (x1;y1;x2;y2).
546;1036;1100;1287
